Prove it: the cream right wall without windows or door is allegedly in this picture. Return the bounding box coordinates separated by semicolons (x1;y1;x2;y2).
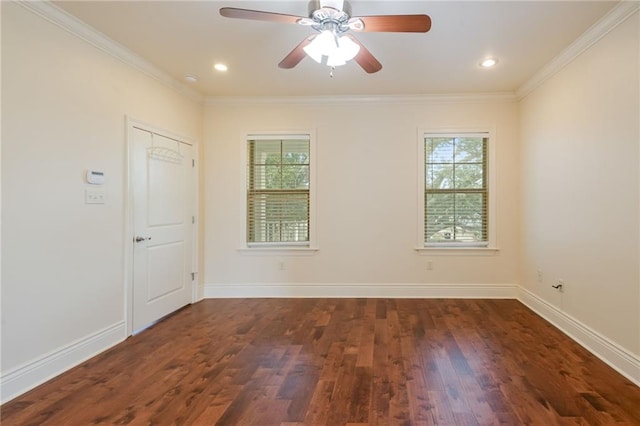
520;13;640;362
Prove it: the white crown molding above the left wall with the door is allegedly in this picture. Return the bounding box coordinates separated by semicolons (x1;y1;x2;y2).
15;0;205;103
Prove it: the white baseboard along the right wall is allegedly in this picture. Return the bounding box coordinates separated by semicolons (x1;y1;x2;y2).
518;287;640;386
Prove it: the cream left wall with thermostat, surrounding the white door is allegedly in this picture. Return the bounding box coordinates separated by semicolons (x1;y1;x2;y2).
2;2;202;400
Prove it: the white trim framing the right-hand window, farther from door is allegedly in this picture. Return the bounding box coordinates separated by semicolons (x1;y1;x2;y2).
415;126;499;255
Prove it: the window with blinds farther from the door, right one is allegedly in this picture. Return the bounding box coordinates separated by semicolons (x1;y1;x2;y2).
423;133;489;247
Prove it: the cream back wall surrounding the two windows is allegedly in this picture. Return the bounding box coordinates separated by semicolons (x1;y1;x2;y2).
204;97;519;297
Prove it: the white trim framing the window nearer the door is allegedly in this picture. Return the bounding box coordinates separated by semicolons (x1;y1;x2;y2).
238;129;318;255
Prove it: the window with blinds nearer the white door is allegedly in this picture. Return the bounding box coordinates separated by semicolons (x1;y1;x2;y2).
246;135;311;246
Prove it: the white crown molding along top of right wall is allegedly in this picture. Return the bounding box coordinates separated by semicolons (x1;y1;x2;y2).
516;0;640;100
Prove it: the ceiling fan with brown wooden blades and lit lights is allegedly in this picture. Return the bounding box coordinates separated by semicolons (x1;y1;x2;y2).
220;0;431;73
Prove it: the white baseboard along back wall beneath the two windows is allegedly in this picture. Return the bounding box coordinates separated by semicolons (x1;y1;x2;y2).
204;284;518;299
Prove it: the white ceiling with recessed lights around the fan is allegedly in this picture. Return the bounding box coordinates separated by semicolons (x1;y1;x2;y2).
54;0;616;96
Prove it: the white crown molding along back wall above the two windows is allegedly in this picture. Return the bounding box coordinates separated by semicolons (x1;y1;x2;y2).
205;92;517;106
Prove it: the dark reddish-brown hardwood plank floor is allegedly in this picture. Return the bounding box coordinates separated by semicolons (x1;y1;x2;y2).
1;299;640;426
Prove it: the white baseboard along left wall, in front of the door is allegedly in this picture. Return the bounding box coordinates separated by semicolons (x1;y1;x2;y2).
0;321;126;404
